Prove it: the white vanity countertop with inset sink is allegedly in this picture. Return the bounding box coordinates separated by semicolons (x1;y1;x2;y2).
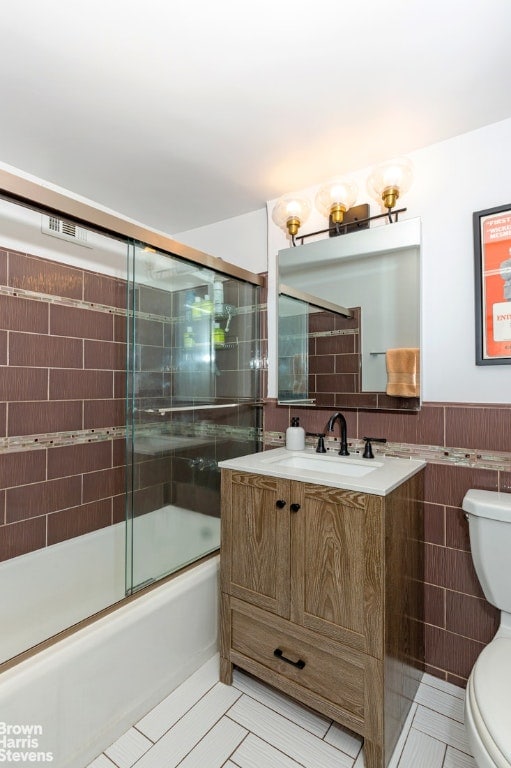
218;448;426;496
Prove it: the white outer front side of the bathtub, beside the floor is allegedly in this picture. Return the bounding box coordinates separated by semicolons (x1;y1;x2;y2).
0;556;219;768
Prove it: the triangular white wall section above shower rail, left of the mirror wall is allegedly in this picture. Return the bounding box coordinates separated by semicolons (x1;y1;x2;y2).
172;208;268;273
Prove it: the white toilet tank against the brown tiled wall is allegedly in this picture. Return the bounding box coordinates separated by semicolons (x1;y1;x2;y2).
462;489;511;613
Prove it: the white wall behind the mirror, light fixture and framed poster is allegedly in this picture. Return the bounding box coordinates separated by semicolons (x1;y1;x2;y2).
268;119;511;403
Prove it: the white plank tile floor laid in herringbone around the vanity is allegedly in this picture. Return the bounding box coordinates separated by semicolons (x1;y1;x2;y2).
88;657;476;768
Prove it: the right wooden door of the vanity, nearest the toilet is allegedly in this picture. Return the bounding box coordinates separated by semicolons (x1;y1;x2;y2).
290;483;383;658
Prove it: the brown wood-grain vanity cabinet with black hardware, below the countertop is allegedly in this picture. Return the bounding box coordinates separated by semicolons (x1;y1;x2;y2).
221;469;423;768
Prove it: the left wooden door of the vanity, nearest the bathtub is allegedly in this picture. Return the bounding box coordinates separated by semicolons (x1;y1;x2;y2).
222;470;290;618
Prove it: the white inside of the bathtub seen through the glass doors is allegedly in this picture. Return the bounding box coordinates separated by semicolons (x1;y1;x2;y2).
0;506;220;664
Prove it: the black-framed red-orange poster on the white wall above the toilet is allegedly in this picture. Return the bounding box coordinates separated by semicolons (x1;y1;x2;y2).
473;204;511;365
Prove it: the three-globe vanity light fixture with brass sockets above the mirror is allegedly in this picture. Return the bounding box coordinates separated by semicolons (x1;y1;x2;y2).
272;157;413;245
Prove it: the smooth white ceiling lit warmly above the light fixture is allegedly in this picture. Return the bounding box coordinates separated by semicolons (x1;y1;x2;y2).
0;0;511;234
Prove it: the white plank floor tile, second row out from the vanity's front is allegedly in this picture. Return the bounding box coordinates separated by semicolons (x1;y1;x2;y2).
229;694;353;768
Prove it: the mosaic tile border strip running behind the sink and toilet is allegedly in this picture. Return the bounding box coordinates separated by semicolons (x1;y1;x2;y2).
263;432;511;472
